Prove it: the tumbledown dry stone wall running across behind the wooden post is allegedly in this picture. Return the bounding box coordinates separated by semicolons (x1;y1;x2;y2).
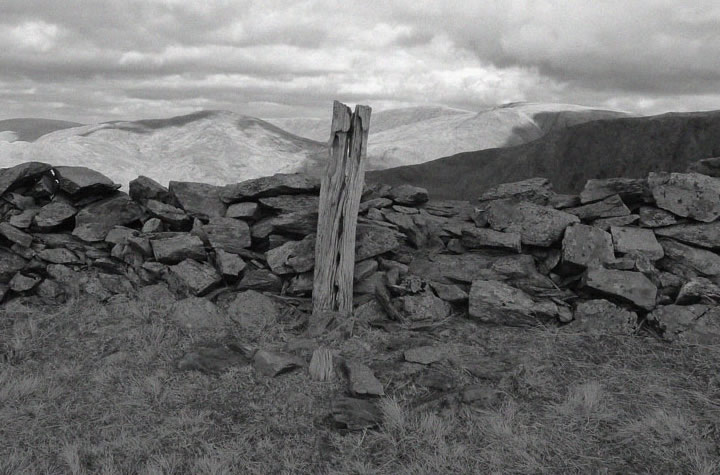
0;159;720;346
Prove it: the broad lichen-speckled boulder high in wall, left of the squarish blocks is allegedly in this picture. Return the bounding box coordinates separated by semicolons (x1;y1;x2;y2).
486;200;580;246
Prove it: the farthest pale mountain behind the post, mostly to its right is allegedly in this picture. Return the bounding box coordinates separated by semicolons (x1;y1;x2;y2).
269;102;629;170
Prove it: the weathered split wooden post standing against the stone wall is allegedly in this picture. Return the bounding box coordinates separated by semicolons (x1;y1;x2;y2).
313;101;372;315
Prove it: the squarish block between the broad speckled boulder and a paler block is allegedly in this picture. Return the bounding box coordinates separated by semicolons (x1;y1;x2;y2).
562;224;615;272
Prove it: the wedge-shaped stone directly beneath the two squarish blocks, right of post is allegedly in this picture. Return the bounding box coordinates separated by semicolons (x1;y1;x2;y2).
583;268;657;310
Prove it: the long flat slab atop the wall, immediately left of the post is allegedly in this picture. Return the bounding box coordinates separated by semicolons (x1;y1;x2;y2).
220;173;320;204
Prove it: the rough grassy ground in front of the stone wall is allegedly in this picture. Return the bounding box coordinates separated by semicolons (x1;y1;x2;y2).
0;292;720;475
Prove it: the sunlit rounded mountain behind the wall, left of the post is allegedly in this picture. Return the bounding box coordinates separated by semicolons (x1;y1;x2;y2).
0;111;327;185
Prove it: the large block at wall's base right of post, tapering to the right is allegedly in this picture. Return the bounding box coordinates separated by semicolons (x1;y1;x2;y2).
469;280;559;326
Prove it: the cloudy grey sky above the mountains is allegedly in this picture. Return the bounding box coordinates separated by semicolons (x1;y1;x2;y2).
0;0;720;123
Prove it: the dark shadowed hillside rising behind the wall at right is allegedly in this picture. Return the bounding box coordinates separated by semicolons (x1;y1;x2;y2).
366;111;720;200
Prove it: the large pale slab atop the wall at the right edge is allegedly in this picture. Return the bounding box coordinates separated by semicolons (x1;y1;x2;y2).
648;172;720;223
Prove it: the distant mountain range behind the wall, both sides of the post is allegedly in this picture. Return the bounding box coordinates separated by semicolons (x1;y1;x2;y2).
0;103;627;185
